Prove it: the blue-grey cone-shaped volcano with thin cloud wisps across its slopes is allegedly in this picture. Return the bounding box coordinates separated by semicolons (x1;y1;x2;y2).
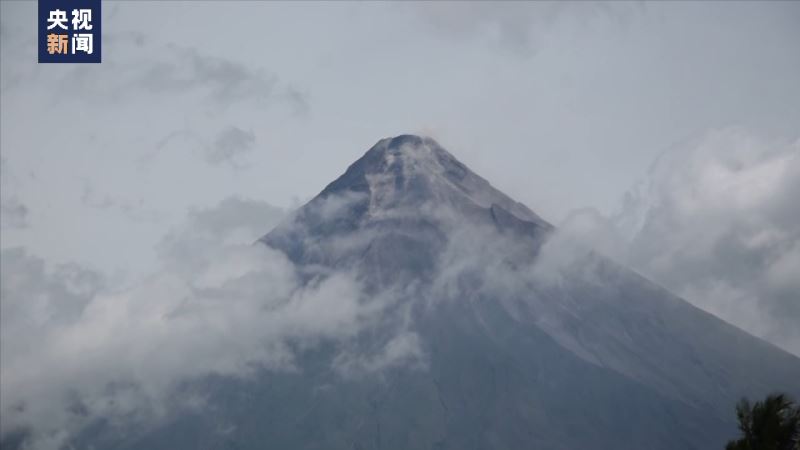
76;136;800;450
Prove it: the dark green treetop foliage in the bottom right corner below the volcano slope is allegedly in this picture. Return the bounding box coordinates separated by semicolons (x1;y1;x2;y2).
725;394;800;450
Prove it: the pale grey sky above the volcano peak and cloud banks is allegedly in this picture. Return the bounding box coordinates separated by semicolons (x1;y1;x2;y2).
1;1;800;273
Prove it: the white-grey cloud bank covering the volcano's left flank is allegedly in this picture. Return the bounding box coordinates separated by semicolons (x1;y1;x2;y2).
0;198;418;449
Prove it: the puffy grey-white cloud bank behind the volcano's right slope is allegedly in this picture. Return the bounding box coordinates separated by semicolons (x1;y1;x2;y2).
561;128;800;355
